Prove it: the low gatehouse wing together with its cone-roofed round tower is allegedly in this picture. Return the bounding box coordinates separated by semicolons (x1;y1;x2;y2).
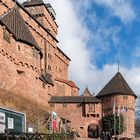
49;72;137;138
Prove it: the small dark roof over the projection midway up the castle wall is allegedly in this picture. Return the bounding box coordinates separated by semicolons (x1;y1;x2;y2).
40;73;54;86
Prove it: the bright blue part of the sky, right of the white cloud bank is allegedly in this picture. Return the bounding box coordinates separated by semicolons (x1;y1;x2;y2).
73;0;140;68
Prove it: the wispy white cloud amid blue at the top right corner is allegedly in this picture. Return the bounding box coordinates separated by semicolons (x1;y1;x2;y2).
94;0;136;23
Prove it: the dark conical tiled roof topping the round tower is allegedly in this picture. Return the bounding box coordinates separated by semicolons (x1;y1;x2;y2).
97;72;137;97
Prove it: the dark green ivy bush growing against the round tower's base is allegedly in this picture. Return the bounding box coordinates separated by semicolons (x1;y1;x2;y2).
102;114;124;135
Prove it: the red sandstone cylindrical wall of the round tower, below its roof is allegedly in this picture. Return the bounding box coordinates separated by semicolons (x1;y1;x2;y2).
102;95;135;137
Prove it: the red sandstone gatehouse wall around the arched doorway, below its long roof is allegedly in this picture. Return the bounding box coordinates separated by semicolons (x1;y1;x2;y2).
51;103;102;137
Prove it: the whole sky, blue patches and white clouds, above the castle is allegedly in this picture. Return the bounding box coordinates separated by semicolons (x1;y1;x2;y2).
20;0;140;96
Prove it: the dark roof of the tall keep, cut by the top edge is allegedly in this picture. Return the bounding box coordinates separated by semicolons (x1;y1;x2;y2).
22;0;44;7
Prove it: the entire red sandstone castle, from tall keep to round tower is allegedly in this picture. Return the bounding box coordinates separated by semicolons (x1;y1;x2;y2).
0;0;137;137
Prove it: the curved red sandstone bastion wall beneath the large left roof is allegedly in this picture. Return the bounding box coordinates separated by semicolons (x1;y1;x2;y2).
0;24;49;106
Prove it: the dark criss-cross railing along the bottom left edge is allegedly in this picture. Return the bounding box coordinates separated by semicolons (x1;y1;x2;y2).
0;133;74;140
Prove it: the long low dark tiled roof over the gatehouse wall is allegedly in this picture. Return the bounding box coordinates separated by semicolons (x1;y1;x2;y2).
49;96;100;103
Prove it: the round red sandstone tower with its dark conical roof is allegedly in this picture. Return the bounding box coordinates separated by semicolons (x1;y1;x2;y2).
97;72;137;138
